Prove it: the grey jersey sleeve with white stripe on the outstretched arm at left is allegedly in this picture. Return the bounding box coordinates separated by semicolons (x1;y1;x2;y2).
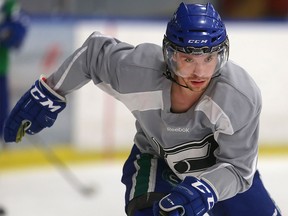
47;32;165;157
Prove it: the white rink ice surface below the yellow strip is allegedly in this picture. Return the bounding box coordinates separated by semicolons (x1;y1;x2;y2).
0;157;288;216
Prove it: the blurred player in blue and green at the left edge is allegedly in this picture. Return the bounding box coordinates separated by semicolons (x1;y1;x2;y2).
0;0;27;215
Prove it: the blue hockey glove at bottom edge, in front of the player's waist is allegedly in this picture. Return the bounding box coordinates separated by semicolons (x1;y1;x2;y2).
154;176;217;216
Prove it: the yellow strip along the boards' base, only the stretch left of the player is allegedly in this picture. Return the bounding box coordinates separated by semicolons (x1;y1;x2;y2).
0;145;129;172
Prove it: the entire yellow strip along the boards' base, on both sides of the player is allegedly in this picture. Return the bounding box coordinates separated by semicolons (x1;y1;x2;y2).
0;143;288;172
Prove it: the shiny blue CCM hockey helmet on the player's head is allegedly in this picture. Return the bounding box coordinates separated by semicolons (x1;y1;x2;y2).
163;2;229;77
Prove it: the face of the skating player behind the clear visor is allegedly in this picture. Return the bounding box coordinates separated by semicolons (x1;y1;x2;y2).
173;52;218;92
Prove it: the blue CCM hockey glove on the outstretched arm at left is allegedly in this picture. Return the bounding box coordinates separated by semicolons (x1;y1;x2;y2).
4;77;66;142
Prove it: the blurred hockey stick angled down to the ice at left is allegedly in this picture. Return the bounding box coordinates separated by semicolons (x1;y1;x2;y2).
25;135;96;197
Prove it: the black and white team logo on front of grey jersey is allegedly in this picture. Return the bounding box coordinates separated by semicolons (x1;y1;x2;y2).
152;134;219;175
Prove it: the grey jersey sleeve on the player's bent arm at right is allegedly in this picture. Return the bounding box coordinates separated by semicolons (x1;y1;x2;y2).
201;63;262;200
